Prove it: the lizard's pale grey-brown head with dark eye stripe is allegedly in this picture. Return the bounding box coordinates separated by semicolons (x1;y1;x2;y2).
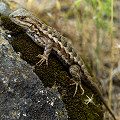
9;9;36;29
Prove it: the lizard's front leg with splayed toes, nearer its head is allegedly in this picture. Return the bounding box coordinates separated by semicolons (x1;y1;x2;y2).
36;39;53;66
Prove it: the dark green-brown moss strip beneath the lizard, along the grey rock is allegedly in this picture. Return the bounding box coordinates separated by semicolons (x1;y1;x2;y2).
1;17;103;120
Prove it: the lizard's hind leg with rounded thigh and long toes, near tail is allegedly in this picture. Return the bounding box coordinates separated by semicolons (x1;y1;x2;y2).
69;65;84;97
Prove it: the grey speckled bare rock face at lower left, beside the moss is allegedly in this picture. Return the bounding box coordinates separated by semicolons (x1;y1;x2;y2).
0;27;67;120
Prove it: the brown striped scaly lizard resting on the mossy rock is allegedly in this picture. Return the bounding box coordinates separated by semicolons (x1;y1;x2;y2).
9;8;116;120
